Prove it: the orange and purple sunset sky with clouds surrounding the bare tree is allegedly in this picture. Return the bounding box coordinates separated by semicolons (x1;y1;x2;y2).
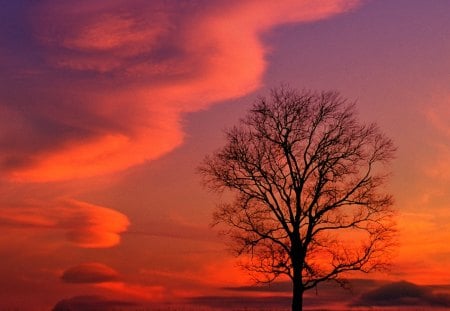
0;0;450;311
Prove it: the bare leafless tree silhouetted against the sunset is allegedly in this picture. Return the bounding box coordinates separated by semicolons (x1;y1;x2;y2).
199;86;395;311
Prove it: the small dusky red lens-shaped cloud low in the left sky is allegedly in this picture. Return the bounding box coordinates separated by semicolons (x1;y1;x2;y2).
61;262;119;283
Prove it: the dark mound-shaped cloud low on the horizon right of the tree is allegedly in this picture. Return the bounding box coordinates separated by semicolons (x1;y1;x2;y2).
355;281;450;307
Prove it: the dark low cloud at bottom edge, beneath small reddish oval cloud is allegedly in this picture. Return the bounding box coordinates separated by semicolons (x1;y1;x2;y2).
52;296;139;311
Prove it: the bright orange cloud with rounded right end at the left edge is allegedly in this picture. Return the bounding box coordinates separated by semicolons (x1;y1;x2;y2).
0;200;129;248
